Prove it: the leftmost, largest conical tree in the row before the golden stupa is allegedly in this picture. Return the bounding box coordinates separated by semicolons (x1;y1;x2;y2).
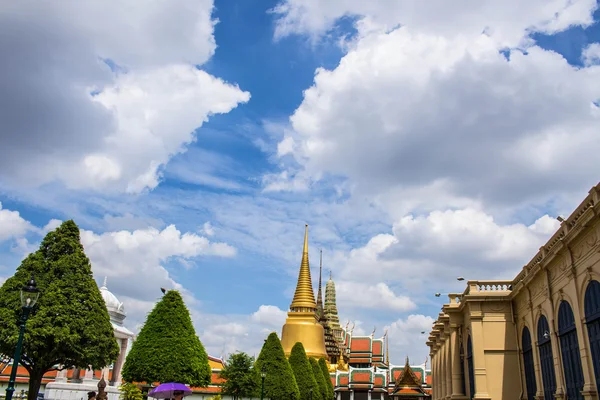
254;332;300;400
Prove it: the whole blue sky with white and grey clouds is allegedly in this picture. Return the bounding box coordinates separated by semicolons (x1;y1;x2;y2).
0;0;600;364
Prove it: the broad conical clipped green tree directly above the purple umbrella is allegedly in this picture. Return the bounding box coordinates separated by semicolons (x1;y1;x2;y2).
122;290;211;387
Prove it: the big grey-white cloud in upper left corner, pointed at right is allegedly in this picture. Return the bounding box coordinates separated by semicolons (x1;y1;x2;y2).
0;0;249;192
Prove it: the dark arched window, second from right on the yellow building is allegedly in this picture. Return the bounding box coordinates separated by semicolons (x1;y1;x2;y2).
558;300;583;400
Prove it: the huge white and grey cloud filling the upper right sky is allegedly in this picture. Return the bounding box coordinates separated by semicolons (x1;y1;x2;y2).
274;27;600;216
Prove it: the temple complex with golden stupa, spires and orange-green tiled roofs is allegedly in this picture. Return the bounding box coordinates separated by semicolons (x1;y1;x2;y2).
281;226;431;400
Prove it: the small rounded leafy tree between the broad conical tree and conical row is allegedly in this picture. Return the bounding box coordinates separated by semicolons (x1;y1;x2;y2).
220;352;260;399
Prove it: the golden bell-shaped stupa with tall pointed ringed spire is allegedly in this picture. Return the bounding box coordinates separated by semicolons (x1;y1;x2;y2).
281;225;327;358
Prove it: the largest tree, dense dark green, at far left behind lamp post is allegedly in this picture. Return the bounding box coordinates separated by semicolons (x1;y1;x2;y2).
0;221;119;400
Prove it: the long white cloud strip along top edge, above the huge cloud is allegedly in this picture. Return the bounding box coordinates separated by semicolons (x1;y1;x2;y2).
273;0;598;46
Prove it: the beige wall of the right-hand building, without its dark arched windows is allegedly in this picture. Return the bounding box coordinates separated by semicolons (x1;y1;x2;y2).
427;186;600;400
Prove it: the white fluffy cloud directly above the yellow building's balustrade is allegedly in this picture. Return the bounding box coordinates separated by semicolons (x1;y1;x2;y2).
333;209;559;298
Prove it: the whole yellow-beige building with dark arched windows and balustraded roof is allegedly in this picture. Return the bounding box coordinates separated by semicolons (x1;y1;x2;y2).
427;184;600;400
